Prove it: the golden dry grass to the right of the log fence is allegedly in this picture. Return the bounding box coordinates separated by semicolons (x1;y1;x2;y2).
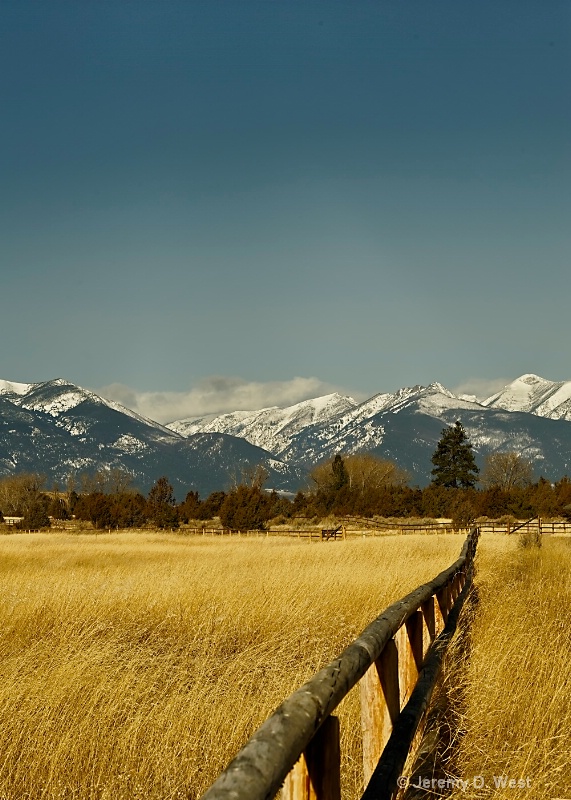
426;536;571;800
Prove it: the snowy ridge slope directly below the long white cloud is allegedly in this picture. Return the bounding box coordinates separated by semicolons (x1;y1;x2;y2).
167;392;357;455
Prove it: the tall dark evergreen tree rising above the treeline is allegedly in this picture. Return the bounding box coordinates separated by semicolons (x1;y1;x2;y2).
432;420;480;489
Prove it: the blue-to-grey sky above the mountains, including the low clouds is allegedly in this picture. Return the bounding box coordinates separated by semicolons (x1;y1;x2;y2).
0;0;571;420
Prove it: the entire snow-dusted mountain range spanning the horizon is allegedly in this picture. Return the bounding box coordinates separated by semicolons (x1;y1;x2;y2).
0;374;571;498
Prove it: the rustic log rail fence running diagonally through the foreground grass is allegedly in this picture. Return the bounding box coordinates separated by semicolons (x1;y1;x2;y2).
203;528;479;800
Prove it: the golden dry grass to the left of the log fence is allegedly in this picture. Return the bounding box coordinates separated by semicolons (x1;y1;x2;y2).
0;534;463;800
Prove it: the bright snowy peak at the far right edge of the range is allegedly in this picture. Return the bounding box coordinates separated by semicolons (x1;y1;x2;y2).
483;374;571;420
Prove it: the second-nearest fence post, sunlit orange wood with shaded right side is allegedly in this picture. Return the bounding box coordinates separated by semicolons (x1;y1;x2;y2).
359;639;400;786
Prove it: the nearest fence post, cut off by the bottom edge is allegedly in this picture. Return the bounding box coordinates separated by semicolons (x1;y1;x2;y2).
282;715;341;800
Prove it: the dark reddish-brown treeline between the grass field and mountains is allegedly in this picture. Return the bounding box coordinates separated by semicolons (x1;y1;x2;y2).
2;477;571;530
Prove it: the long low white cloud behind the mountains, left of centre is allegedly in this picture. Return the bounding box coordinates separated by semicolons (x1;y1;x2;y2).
95;375;348;423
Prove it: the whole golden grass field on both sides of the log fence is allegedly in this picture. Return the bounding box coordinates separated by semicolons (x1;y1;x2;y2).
0;533;571;800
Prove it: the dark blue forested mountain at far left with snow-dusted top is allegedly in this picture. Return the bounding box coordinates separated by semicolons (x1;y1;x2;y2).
0;379;299;498
